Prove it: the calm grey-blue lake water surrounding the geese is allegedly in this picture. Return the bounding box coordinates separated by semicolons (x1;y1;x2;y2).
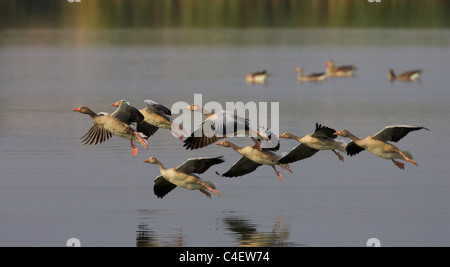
0;28;450;246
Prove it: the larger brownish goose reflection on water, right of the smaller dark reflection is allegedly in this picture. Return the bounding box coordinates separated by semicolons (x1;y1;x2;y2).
223;216;294;247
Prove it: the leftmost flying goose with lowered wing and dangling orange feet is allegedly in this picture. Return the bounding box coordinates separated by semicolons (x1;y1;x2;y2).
73;106;148;156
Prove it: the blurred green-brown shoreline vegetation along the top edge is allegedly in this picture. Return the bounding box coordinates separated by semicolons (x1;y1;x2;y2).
0;0;450;29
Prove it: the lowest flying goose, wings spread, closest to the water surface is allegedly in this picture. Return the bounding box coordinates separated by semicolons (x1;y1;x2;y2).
144;156;225;198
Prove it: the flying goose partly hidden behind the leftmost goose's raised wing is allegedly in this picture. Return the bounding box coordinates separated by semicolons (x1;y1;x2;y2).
137;99;183;141
